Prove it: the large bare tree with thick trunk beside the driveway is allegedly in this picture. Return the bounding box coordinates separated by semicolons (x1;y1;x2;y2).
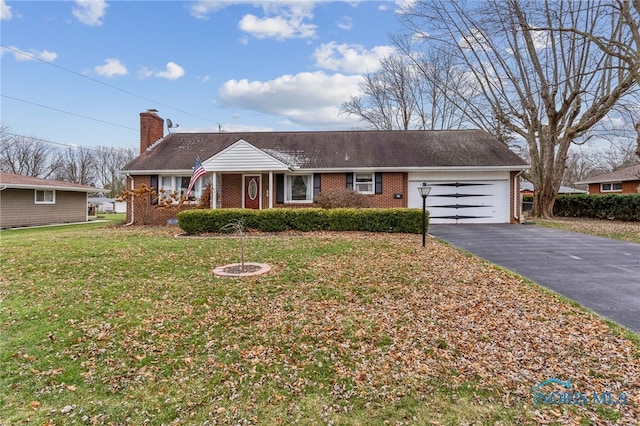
402;0;637;217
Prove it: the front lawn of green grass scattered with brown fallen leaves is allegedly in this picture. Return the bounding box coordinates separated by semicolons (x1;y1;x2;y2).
0;227;640;425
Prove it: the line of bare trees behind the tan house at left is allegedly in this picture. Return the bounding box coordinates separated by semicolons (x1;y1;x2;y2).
0;126;137;197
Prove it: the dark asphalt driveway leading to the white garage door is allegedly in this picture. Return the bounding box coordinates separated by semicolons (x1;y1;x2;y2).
429;224;640;333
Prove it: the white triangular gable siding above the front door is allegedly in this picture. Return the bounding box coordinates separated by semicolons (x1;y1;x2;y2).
202;139;289;172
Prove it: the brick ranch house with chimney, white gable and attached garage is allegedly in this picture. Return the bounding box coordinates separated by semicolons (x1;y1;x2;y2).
122;110;528;224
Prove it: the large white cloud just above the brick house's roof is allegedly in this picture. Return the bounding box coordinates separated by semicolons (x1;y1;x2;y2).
219;71;362;128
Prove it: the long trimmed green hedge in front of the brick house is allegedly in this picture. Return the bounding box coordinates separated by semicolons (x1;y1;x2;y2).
178;208;422;235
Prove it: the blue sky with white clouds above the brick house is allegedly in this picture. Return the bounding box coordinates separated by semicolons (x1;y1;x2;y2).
0;0;410;149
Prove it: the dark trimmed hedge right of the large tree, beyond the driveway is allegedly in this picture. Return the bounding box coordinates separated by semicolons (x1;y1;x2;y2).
553;194;640;221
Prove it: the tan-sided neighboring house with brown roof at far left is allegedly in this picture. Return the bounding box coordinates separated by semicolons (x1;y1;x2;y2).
0;173;101;229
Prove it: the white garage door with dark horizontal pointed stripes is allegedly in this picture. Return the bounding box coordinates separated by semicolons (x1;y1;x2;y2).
409;180;509;223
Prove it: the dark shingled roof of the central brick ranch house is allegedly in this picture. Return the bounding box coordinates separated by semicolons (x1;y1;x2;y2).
123;130;527;172
